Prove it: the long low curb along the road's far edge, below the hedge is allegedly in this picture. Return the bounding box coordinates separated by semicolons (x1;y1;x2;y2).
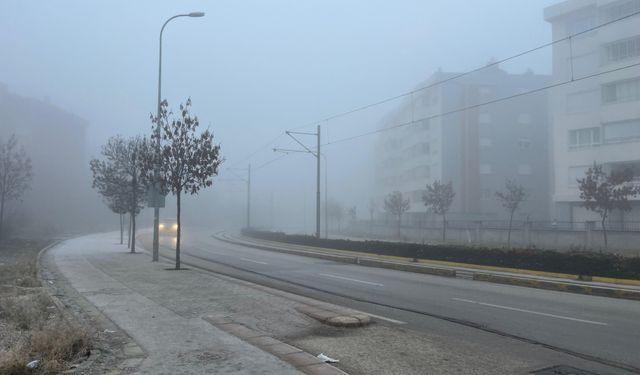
213;234;640;301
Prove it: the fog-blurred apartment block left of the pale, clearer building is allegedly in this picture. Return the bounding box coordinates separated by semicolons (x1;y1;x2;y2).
375;66;550;221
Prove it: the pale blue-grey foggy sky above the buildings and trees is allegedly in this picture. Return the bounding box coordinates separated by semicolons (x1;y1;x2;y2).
0;0;558;232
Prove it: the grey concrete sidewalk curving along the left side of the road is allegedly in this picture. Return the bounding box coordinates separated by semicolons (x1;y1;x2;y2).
48;233;344;375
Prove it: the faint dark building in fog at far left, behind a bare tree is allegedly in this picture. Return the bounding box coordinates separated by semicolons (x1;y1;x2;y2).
0;83;92;235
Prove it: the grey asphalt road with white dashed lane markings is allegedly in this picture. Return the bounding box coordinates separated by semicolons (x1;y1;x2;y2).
145;232;640;373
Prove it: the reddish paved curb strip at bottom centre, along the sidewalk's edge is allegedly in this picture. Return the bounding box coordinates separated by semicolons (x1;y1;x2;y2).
202;316;348;375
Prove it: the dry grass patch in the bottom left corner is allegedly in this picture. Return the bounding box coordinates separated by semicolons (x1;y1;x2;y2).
0;241;92;375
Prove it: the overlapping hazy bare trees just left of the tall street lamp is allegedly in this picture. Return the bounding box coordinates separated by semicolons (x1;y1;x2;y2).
89;136;151;253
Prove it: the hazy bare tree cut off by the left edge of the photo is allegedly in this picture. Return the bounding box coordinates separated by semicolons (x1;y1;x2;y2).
0;135;33;236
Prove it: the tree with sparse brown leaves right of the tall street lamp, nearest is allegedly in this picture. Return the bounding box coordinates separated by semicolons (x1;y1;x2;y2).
154;98;223;269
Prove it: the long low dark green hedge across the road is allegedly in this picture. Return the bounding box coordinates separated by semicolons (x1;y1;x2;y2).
242;229;640;279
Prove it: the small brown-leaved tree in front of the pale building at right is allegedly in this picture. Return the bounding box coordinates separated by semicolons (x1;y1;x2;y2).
577;162;640;250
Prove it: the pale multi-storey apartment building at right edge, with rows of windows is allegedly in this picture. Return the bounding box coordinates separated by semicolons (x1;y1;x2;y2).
544;0;640;221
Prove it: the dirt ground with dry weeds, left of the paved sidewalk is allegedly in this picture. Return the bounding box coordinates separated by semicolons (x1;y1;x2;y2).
0;240;128;375
